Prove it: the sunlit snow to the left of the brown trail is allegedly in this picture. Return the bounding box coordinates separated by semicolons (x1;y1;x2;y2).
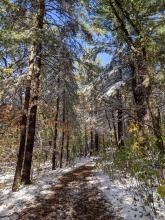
0;157;92;220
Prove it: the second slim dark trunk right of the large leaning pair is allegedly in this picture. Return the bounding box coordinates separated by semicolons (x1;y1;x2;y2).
60;91;66;168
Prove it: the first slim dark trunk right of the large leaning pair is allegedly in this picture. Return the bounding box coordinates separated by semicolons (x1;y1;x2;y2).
52;79;60;170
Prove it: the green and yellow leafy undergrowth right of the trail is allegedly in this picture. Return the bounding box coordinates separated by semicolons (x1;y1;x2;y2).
97;133;165;215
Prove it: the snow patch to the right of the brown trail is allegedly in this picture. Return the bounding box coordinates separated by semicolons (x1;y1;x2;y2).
95;172;165;220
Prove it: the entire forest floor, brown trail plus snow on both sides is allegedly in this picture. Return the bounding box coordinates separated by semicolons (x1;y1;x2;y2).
0;157;165;220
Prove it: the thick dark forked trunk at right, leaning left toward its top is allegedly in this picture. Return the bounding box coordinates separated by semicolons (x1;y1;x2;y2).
109;0;150;138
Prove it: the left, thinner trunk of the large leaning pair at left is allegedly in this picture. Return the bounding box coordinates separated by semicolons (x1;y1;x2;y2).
12;45;35;192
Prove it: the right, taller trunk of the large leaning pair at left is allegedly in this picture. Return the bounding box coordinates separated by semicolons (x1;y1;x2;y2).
22;0;45;184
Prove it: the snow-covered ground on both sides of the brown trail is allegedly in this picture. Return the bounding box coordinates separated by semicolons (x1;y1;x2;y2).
0;157;165;220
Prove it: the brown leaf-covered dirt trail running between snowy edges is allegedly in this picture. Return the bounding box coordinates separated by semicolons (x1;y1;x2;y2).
19;165;119;220
